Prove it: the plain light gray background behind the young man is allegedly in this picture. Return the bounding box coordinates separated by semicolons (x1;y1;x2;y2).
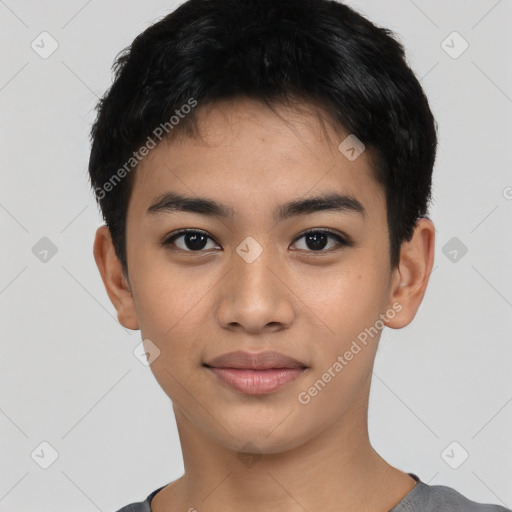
0;0;512;512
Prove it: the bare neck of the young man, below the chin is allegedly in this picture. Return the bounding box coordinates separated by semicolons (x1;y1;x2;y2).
152;378;415;512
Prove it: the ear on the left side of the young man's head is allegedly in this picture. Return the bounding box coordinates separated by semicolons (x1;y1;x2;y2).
93;226;140;330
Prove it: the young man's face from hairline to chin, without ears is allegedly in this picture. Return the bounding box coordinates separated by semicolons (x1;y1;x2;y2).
107;100;408;453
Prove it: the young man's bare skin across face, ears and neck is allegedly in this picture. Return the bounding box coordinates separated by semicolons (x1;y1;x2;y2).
94;99;435;512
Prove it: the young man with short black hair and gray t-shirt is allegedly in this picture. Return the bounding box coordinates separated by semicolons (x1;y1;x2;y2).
89;0;505;512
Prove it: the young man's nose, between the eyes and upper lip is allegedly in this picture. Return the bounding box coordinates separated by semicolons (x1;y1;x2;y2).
217;245;295;334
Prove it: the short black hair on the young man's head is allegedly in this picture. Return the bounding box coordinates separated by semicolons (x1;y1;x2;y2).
89;0;437;276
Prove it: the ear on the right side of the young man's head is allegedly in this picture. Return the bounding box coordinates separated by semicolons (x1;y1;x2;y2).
386;217;436;329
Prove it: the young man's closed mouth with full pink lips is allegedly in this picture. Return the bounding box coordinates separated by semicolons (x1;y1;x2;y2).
203;351;308;395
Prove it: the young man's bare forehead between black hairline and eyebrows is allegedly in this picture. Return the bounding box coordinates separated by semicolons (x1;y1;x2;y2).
130;99;385;222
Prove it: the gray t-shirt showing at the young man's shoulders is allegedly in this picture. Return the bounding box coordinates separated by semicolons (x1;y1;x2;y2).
117;473;512;512
